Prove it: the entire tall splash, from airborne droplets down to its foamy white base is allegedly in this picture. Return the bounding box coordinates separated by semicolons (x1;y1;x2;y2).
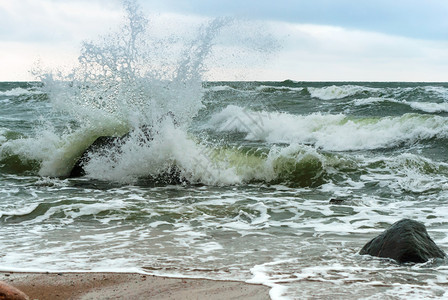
5;0;284;184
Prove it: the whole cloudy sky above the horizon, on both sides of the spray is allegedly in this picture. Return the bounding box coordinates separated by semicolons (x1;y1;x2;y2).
0;0;448;82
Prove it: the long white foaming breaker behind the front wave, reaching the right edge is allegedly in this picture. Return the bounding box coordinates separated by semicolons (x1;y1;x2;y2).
208;105;448;151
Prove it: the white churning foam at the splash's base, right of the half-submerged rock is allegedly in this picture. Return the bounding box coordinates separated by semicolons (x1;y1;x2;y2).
85;124;241;184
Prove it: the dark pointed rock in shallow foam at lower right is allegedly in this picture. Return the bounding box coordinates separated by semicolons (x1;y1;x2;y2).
359;219;446;263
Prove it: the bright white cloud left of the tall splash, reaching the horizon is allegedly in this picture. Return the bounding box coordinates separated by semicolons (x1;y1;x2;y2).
0;0;123;81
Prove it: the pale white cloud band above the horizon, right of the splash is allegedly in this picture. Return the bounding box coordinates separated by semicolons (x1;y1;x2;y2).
260;22;448;81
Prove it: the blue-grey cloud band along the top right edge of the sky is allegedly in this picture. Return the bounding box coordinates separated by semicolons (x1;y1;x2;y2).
143;0;448;39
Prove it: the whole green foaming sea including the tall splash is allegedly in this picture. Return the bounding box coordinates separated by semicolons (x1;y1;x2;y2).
0;3;448;299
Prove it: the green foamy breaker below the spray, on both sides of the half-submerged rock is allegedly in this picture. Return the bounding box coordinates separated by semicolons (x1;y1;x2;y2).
0;120;348;186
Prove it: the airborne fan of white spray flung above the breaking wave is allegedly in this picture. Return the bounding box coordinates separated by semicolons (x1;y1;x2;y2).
40;1;228;130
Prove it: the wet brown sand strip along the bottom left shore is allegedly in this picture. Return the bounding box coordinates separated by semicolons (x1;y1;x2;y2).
0;271;270;300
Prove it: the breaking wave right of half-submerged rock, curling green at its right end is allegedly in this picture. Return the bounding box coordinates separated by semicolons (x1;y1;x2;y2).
79;123;325;186
